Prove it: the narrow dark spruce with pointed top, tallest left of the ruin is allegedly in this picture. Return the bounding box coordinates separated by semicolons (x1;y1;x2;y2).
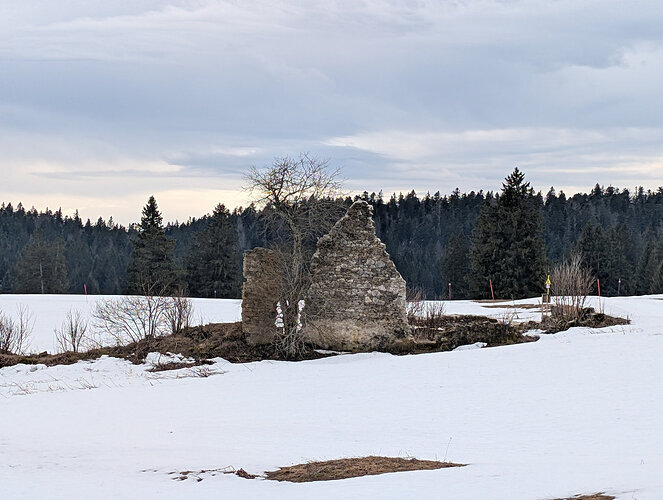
127;196;181;295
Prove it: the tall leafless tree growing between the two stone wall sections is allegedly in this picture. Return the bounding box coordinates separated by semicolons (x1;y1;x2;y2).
247;154;343;356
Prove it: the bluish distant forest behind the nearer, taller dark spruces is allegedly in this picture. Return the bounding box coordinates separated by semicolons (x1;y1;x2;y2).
0;176;663;298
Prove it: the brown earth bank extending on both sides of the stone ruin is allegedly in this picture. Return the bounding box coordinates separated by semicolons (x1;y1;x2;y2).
0;304;630;371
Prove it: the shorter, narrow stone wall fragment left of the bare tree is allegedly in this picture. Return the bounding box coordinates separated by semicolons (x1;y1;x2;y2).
242;248;281;345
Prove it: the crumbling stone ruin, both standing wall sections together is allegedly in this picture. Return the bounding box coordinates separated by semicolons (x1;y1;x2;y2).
242;197;409;351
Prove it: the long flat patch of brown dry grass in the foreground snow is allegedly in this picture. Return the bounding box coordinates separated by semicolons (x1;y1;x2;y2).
265;457;465;483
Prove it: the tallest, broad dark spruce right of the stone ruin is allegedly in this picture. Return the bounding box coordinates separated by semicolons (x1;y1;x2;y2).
470;168;546;298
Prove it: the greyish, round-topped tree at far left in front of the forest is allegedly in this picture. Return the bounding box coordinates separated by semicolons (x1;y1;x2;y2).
14;230;69;293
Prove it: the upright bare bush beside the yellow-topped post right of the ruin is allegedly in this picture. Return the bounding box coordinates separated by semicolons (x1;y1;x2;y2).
551;254;594;323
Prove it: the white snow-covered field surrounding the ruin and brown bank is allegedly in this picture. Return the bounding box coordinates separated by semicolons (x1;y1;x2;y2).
0;296;663;500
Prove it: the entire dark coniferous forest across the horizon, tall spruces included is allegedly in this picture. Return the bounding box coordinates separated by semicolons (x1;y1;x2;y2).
0;169;663;299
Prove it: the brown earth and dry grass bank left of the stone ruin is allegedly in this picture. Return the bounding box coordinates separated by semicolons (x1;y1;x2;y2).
0;323;331;369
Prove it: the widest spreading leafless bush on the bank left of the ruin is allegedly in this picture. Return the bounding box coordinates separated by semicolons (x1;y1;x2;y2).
92;295;170;345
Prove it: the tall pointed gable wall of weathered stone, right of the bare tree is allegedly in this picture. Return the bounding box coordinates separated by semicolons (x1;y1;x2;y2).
304;201;409;351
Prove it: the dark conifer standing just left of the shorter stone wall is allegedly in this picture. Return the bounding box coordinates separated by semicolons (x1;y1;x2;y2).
186;204;241;298
